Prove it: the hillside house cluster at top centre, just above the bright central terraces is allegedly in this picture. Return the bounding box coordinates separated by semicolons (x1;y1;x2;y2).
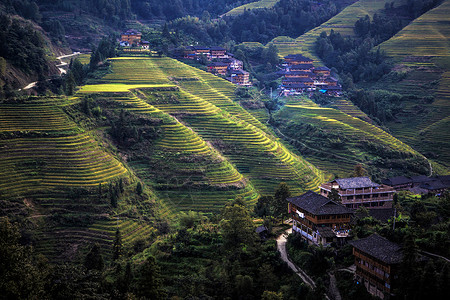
177;46;252;86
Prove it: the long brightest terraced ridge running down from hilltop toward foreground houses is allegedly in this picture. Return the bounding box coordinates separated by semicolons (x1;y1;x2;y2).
92;58;323;202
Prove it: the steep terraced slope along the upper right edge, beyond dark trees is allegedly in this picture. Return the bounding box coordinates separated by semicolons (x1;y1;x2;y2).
381;1;450;172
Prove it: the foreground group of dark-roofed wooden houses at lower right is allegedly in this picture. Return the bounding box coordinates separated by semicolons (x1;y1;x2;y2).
287;176;450;299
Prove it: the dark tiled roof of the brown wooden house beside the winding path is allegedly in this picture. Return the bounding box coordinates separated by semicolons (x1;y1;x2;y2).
286;191;353;215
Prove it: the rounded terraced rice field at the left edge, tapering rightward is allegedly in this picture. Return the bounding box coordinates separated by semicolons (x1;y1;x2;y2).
0;99;127;195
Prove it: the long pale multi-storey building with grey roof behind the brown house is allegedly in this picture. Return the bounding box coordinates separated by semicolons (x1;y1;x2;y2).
319;177;395;209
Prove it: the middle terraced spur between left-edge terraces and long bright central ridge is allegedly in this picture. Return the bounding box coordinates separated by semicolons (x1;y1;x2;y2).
87;85;258;213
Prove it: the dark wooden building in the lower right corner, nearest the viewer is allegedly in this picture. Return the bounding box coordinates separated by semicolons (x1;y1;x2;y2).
349;234;403;299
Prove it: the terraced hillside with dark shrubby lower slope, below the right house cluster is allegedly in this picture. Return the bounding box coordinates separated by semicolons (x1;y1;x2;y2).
274;98;429;180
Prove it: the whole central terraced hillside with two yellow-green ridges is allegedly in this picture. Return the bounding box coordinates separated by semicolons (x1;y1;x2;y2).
81;58;324;204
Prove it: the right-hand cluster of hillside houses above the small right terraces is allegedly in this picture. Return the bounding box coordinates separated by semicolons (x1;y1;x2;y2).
278;54;342;96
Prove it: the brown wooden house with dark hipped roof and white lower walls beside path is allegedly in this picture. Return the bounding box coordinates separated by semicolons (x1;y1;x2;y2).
287;191;353;245
